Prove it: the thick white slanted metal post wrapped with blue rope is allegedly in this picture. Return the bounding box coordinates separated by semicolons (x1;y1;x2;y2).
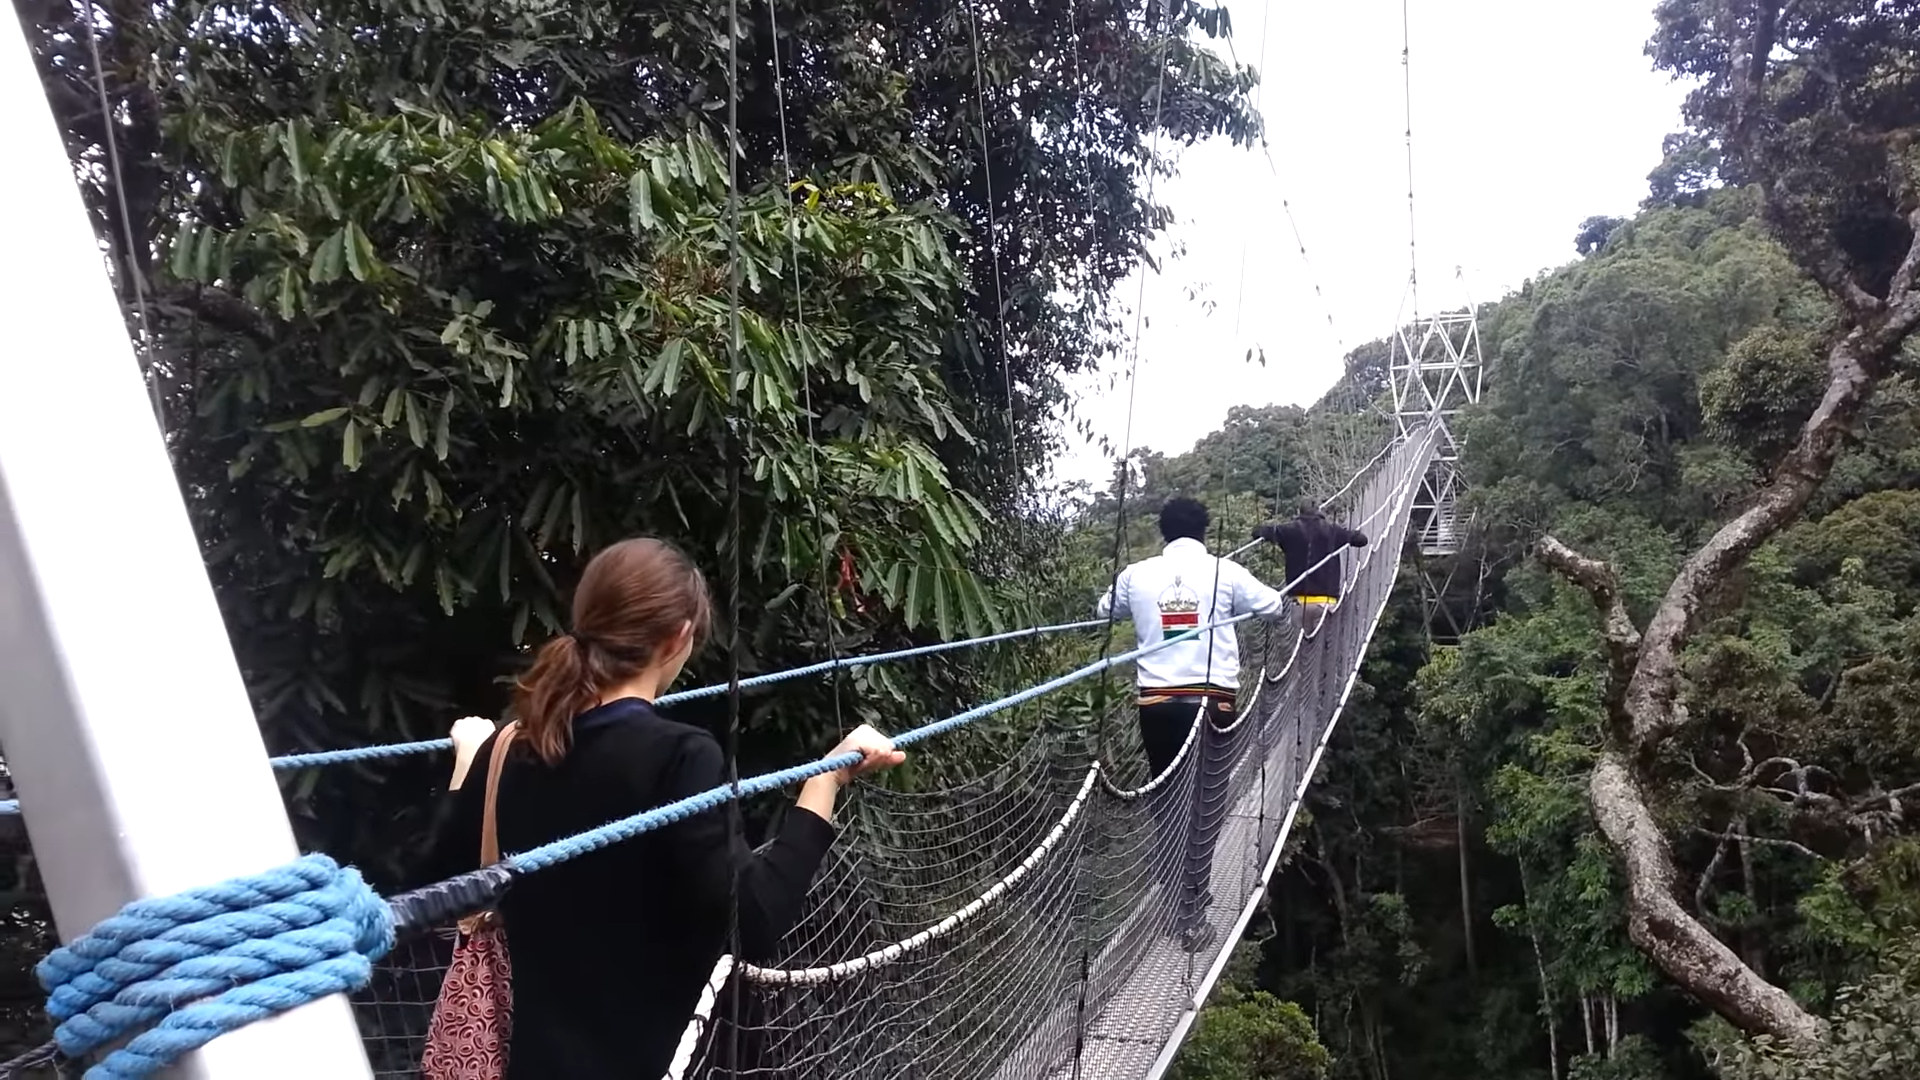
0;15;371;1080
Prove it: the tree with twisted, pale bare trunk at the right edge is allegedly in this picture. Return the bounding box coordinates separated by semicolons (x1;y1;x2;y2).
1497;0;1920;1047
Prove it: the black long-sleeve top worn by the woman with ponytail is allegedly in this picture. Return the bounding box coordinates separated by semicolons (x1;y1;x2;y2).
432;698;833;1080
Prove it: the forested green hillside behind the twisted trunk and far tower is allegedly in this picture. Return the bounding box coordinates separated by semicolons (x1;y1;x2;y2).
1113;166;1920;1080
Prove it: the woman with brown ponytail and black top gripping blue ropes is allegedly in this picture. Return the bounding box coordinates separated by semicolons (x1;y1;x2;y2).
434;538;904;1080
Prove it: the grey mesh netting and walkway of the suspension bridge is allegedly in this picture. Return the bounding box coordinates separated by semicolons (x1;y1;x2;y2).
355;430;1434;1080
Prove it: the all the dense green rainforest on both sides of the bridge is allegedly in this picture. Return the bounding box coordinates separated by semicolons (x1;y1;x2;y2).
0;0;1920;1080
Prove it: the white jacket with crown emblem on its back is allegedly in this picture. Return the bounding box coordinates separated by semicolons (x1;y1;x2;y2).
1094;540;1286;690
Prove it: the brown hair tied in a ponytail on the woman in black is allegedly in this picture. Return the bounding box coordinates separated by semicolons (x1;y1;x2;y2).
513;538;712;765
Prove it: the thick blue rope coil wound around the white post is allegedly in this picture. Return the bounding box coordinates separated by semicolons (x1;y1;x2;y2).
36;855;394;1080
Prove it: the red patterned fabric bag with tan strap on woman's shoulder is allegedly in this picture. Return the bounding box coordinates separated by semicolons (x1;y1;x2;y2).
420;723;520;1080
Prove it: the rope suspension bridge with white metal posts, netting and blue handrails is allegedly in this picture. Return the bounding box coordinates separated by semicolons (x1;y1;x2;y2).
0;0;1480;1080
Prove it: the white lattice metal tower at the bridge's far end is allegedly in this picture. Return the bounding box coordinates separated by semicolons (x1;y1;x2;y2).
1390;282;1480;555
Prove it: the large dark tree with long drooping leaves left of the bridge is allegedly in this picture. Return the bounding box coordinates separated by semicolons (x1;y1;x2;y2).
17;0;1260;855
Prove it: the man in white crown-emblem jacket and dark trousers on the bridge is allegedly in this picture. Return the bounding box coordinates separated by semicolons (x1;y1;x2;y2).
1094;498;1286;951
